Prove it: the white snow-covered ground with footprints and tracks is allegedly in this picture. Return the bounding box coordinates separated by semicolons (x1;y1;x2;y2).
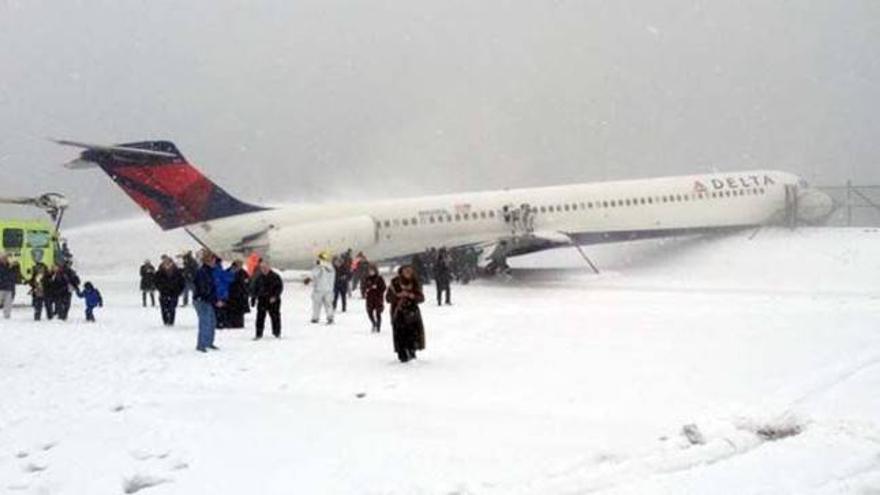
0;220;880;495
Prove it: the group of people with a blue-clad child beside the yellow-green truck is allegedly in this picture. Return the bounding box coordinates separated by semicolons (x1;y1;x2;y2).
0;254;104;322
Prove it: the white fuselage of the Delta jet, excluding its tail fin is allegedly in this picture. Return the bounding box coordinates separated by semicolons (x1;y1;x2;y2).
187;170;831;269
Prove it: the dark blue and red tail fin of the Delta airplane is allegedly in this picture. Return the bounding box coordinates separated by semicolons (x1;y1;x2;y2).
56;140;265;230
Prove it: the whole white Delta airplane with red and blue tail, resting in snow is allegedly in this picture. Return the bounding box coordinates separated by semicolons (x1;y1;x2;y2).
56;140;835;269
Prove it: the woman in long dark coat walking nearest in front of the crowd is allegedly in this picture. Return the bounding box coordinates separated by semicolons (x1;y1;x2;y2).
385;265;425;363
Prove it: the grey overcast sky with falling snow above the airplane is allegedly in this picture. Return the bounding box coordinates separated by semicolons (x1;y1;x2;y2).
0;0;880;223
